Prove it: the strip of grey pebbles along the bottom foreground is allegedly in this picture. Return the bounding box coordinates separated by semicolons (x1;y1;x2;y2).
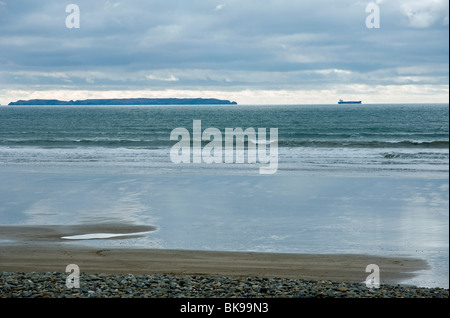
0;272;449;298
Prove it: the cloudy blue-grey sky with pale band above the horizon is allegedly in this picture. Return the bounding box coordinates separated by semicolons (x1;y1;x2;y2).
0;0;449;105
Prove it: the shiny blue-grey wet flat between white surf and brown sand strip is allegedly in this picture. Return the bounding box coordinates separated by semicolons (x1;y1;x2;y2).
0;168;448;288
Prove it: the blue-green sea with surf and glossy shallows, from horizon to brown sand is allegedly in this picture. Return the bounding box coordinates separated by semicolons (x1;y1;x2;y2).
0;104;449;288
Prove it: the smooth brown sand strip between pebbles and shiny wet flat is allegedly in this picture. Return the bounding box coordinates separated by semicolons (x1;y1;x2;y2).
0;243;429;285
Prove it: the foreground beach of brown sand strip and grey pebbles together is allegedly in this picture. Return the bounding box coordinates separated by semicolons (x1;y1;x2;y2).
0;244;448;298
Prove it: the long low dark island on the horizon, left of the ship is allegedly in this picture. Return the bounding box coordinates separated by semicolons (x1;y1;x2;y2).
8;98;237;106
